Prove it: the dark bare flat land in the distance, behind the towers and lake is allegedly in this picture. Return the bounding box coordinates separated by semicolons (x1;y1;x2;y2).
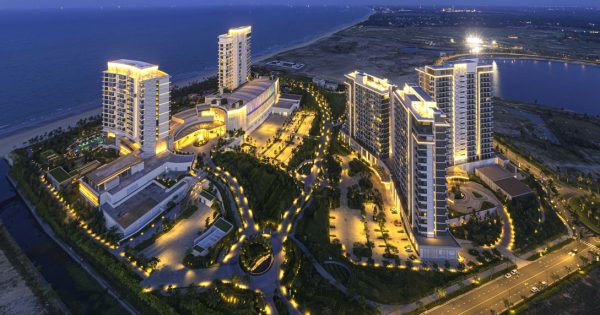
262;25;600;84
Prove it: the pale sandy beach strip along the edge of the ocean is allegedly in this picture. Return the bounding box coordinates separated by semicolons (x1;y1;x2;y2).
0;9;374;157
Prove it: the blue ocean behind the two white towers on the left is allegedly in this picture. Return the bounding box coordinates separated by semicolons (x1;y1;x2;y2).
0;6;371;137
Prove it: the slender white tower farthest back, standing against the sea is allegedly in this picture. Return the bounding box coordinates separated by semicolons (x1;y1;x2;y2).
218;26;252;93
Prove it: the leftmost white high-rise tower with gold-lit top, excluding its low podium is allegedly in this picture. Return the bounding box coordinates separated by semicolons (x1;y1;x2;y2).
102;59;170;156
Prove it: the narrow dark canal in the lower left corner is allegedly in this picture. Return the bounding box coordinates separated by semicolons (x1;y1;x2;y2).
0;160;125;314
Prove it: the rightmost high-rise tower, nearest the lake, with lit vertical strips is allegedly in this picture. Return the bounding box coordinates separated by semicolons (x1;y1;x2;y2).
417;59;493;166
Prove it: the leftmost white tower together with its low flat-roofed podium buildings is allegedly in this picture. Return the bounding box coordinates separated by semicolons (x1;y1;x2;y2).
79;59;195;238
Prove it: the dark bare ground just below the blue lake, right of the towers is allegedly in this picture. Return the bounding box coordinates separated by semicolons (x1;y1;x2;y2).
494;100;600;180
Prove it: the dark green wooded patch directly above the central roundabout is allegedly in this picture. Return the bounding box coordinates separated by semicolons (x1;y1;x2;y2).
214;152;299;228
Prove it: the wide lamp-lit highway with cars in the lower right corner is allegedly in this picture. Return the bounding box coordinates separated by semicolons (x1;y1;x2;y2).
426;241;591;314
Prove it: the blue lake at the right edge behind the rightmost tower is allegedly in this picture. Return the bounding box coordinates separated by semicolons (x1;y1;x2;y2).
490;59;600;115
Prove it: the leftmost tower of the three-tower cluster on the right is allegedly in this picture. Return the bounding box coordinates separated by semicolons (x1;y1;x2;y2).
345;71;393;159
